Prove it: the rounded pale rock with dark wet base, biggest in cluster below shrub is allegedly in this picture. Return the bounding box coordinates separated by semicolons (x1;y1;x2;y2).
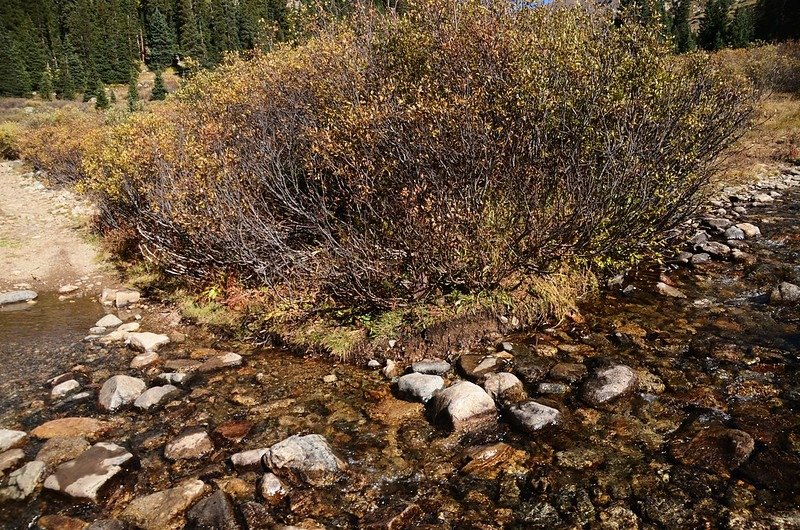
431;381;497;431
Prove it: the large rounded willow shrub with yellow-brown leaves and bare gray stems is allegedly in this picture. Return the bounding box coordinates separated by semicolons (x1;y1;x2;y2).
85;0;753;308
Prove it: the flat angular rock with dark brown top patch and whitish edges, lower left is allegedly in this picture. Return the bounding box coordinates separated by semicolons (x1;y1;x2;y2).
44;442;133;502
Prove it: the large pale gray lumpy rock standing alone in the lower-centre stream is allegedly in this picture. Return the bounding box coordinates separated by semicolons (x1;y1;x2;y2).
263;434;347;486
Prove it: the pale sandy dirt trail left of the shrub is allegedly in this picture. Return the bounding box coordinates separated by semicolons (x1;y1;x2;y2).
0;162;111;291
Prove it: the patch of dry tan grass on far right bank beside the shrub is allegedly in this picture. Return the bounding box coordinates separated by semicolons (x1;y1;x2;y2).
718;94;800;184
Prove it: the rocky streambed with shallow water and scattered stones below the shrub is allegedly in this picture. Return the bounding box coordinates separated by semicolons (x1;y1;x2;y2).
0;167;800;530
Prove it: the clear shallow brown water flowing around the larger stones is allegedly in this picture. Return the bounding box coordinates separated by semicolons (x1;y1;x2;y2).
0;179;800;529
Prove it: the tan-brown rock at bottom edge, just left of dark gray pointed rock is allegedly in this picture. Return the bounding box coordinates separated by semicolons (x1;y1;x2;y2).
121;479;208;530
